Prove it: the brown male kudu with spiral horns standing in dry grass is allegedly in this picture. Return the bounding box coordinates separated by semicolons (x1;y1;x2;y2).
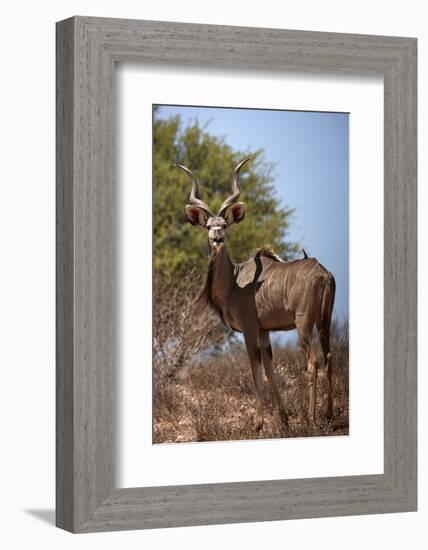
176;158;335;430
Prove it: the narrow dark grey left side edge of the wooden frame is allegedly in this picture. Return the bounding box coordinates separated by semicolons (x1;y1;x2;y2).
56;18;75;530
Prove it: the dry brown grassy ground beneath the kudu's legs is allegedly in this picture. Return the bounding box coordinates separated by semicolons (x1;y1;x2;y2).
153;339;349;443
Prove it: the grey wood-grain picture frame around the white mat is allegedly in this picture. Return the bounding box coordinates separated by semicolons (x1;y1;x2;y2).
56;17;417;533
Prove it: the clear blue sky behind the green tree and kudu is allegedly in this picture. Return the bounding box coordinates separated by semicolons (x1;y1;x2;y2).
157;106;349;320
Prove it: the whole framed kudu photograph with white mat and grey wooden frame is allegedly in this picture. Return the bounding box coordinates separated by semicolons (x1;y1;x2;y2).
57;17;417;532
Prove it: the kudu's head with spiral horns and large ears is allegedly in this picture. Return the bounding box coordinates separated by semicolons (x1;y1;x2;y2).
175;158;250;255
